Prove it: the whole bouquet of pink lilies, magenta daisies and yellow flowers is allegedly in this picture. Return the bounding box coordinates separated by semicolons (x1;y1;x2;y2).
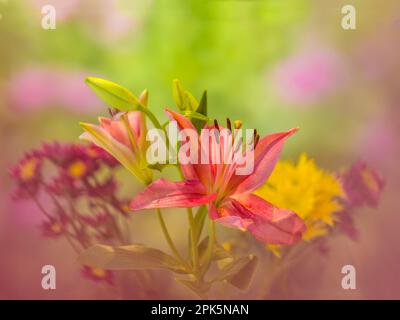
10;78;384;298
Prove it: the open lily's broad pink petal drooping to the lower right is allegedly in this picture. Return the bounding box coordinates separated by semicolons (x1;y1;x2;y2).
230;194;306;245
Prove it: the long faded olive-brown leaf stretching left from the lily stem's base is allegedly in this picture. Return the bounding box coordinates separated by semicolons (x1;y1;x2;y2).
78;244;185;273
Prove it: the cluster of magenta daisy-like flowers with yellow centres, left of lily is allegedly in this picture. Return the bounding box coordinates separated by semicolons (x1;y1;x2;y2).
10;142;127;248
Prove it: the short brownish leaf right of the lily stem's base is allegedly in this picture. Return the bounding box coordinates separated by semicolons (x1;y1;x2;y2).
212;255;258;290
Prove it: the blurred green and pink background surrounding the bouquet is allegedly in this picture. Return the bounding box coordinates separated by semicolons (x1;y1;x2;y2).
0;0;400;299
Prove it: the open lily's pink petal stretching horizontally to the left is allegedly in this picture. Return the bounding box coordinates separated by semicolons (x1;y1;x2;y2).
130;179;217;211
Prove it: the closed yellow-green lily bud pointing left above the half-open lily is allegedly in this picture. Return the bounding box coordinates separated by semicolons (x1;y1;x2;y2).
85;77;140;111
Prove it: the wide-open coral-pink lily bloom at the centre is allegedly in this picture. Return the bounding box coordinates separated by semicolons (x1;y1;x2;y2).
130;110;306;245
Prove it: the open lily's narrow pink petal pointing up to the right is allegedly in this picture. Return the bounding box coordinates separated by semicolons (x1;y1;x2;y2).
231;128;298;194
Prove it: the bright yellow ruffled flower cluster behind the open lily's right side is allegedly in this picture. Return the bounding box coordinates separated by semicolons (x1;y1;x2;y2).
255;154;344;246
